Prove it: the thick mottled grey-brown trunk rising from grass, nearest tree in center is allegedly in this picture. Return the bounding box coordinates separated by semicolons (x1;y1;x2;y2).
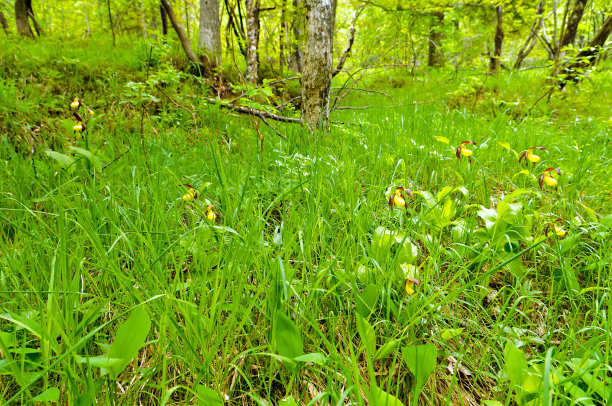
301;0;334;130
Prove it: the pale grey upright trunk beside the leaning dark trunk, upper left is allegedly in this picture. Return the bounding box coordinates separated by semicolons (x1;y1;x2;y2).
198;0;221;67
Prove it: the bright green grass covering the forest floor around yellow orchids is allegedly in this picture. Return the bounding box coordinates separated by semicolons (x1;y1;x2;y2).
0;39;612;405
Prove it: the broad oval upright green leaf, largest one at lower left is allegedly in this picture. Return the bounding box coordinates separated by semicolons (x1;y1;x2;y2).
102;306;151;379
